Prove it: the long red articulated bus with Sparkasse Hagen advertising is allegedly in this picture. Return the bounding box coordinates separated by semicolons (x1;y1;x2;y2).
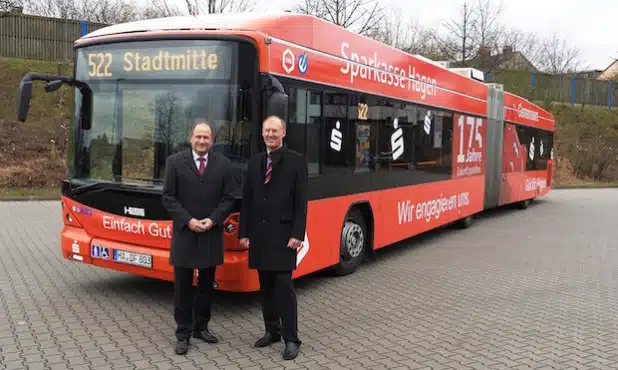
19;12;554;292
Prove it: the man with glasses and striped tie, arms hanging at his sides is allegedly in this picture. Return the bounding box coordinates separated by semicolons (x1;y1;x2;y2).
239;116;308;360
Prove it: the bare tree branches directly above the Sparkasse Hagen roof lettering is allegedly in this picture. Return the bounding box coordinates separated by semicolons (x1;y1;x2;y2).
294;0;384;35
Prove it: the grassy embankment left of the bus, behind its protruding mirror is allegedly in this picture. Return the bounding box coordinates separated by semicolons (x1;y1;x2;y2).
0;58;71;197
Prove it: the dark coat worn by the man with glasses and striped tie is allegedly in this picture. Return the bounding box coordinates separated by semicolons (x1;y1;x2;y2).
239;148;308;271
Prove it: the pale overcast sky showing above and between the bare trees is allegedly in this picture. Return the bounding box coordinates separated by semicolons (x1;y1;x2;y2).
244;0;618;70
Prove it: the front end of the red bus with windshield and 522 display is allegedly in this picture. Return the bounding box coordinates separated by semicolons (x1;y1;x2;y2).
53;34;261;291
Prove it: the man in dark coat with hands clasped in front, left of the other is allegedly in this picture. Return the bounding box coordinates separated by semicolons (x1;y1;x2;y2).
163;121;235;355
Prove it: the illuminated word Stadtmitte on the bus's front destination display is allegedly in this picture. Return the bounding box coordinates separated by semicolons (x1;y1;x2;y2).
123;50;219;72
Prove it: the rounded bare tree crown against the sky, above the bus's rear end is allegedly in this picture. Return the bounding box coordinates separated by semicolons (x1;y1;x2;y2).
539;34;582;75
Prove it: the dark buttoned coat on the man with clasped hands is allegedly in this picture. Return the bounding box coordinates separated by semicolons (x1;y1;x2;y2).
163;149;237;268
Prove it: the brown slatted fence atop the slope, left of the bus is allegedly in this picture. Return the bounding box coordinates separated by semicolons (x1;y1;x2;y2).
0;13;106;61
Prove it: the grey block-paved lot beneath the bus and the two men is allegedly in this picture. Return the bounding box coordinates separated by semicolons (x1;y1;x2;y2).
0;189;618;369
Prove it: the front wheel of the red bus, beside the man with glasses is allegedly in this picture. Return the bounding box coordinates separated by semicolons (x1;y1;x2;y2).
334;208;369;276
